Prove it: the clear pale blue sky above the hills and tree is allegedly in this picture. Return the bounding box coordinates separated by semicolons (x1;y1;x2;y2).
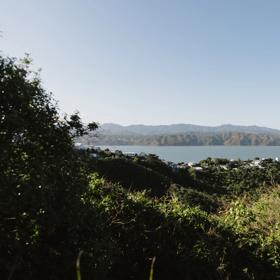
0;0;280;129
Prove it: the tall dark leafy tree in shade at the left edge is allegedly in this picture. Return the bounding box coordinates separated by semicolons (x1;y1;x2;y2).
0;56;97;279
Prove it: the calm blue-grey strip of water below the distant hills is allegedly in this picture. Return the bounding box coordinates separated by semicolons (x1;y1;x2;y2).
100;146;280;162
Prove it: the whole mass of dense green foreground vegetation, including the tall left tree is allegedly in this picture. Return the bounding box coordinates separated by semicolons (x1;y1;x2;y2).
0;57;280;280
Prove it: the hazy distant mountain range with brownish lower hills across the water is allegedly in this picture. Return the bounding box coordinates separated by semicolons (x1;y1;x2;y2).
79;123;280;146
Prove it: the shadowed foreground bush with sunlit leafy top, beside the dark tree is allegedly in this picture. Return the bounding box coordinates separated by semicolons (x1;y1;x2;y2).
79;176;276;279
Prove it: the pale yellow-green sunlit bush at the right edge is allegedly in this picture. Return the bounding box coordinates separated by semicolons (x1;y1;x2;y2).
223;187;280;269
